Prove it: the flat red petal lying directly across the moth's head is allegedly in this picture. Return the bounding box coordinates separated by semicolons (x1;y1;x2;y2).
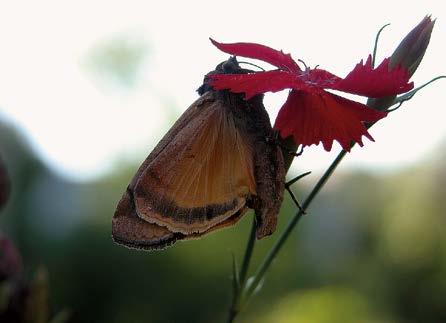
208;71;306;99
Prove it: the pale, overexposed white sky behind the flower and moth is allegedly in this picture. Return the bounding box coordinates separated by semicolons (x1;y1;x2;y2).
0;0;446;179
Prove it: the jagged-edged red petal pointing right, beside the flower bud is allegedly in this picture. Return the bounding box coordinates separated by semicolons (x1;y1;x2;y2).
323;55;413;98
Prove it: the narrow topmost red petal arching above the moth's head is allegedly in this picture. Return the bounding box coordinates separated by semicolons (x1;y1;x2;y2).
209;38;300;72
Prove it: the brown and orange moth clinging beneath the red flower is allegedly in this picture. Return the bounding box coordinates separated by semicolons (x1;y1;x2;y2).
112;57;285;250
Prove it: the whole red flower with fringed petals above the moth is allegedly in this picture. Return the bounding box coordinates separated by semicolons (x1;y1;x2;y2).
209;39;413;151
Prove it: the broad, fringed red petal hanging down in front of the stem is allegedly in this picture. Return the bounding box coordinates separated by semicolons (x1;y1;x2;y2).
274;91;387;151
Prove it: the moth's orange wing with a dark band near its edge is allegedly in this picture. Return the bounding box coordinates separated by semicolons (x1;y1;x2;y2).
131;91;256;234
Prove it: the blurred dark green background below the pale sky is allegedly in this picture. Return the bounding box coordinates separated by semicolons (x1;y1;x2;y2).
0;112;446;323
